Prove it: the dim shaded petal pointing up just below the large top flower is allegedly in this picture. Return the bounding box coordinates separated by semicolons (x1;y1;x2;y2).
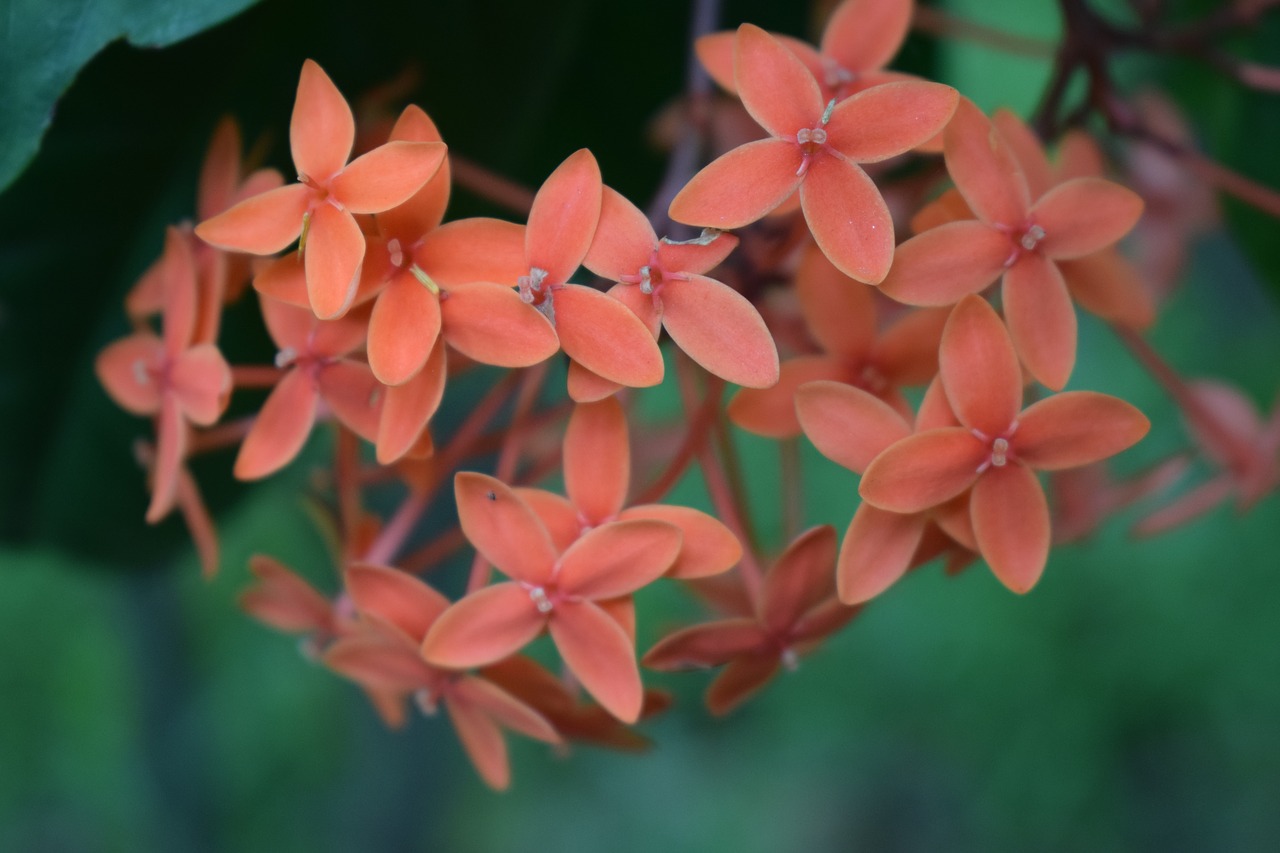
795;240;876;361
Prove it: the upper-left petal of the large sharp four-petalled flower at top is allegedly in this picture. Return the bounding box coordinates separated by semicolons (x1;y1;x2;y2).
733;24;824;141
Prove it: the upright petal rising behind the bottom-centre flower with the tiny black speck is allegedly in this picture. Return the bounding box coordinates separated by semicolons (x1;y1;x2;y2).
564;398;631;525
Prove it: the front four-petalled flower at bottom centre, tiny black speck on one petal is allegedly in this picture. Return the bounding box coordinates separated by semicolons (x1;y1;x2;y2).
422;471;681;722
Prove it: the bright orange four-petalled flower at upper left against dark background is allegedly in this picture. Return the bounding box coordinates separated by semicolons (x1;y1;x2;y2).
196;59;445;319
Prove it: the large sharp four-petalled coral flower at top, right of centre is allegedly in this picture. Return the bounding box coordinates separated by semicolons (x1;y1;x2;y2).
669;24;957;284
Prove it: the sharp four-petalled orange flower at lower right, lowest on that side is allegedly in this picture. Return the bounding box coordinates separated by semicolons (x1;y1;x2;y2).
859;296;1151;593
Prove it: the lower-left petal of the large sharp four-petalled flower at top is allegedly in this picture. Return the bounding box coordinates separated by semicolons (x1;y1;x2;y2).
668;140;803;229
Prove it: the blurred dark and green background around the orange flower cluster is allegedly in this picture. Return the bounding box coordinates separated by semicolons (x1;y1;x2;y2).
0;0;1280;852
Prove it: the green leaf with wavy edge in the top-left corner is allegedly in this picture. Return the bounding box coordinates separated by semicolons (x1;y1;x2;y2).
0;0;256;190
